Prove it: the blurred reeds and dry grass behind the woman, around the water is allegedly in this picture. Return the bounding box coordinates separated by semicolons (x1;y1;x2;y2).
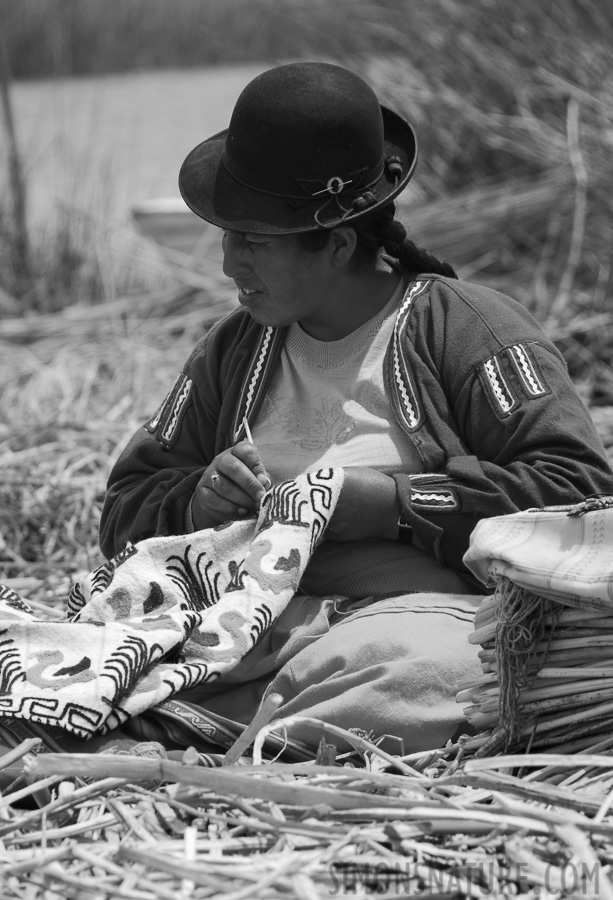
0;0;613;593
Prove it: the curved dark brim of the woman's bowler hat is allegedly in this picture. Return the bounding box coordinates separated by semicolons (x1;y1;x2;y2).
179;106;417;234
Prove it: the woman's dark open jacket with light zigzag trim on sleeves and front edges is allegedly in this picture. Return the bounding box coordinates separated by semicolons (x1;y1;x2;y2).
100;275;613;571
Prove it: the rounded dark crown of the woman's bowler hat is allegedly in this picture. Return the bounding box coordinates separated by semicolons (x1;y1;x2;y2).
223;63;384;198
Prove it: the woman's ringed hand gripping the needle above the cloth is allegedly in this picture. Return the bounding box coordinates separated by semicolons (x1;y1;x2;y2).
192;441;271;531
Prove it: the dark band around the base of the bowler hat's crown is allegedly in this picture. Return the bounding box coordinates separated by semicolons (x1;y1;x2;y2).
221;147;384;202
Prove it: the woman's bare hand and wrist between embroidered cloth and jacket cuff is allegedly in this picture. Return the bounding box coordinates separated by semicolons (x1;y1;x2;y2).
325;466;400;541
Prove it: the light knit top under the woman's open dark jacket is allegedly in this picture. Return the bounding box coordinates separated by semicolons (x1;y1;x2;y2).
252;279;423;484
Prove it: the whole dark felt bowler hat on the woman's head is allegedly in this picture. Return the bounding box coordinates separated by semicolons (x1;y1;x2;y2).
179;62;417;234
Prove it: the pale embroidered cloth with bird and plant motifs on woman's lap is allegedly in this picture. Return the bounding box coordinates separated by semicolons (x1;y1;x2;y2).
0;469;343;737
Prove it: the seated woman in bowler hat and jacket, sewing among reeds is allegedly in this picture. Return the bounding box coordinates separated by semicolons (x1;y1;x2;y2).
101;63;613;751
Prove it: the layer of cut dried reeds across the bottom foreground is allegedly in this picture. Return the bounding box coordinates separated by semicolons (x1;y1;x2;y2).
0;747;613;900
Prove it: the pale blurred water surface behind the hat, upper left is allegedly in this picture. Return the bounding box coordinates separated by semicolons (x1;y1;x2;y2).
0;64;267;229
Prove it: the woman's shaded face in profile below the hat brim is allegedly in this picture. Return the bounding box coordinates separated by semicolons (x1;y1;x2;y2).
222;231;327;333
